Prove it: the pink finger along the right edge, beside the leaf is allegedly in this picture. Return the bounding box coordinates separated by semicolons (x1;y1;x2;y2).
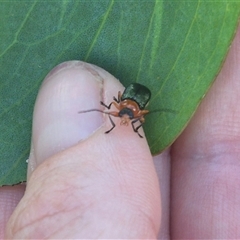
171;25;240;239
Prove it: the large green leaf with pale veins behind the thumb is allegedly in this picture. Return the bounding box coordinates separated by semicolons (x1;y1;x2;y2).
0;0;240;185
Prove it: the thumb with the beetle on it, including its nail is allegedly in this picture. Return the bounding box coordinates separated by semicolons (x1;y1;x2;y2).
6;62;160;239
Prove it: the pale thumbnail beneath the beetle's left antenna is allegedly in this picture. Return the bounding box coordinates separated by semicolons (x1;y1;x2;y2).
28;61;103;173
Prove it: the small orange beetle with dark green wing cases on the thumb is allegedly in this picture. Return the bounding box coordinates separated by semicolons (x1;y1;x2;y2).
78;83;151;138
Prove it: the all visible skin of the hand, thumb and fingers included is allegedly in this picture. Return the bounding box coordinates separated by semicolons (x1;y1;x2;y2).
0;26;240;239
